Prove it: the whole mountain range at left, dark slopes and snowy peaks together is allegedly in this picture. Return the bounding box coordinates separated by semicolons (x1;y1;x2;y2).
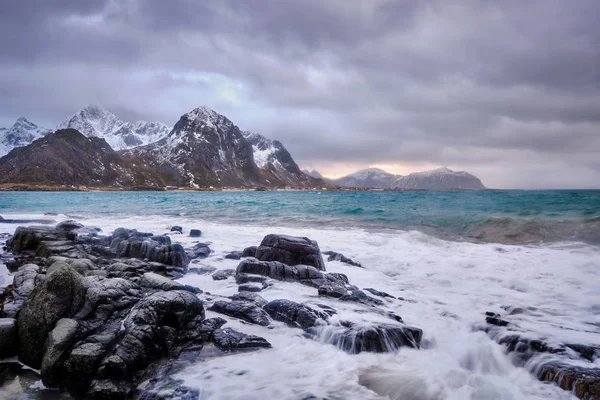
0;106;324;188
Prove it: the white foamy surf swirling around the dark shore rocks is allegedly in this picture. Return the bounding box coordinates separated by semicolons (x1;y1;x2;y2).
0;211;600;400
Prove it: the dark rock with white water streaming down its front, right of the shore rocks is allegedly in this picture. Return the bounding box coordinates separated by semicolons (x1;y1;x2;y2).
327;324;423;354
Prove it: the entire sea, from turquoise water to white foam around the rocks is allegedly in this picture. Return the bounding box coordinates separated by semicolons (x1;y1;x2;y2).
0;190;600;400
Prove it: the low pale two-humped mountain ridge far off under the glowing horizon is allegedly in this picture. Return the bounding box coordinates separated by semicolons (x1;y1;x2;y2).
326;167;486;190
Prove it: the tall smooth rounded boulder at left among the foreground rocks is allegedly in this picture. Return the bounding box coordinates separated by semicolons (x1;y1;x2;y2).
18;262;87;369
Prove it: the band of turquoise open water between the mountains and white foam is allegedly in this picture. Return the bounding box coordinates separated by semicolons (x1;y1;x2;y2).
0;190;600;244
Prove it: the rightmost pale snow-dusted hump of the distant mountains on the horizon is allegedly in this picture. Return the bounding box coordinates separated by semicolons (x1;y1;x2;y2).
390;167;485;190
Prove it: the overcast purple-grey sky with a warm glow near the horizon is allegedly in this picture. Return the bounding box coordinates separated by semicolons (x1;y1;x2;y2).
0;0;600;189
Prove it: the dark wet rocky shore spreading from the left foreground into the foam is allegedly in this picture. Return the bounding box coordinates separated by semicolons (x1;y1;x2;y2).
0;221;422;399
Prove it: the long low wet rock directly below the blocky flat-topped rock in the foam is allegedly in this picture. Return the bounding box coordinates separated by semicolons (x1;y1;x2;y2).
236;258;327;287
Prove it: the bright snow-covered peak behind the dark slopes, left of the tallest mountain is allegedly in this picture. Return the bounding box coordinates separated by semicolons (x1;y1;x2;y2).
57;105;171;150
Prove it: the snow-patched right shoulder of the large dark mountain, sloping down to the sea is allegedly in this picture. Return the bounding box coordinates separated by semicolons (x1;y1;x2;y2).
242;131;317;186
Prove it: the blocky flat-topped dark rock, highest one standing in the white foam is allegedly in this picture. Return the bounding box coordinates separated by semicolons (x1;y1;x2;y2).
255;235;325;271
